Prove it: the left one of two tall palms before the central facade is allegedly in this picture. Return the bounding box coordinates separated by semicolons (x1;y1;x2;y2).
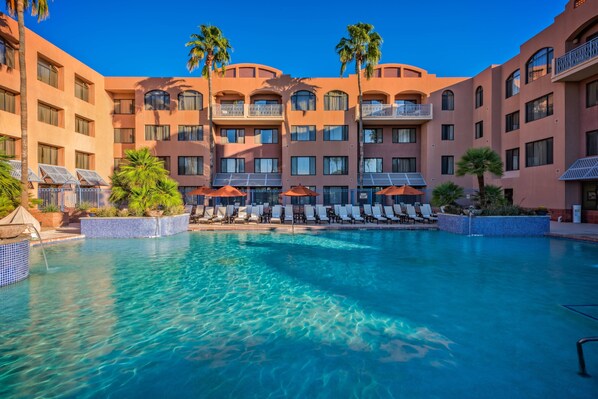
186;25;232;188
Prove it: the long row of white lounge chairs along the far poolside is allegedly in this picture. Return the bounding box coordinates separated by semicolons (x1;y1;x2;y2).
189;204;438;223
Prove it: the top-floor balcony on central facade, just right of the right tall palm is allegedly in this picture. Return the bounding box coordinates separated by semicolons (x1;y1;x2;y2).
356;104;432;125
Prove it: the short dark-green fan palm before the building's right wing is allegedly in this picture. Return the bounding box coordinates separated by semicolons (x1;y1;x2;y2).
456;147;503;209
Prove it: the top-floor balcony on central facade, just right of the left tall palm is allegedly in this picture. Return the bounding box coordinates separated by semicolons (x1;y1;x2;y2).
212;104;284;125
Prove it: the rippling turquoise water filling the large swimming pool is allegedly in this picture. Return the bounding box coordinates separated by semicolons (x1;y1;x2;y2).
0;231;598;399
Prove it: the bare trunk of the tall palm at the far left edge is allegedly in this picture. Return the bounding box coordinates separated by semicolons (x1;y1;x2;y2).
17;0;29;208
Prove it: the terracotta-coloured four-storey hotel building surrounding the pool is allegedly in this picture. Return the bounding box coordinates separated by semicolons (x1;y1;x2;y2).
0;0;598;223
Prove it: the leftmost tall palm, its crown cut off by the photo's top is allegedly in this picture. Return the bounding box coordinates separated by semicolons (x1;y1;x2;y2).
6;0;50;208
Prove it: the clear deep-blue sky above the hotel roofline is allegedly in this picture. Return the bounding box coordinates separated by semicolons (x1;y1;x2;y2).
0;0;566;77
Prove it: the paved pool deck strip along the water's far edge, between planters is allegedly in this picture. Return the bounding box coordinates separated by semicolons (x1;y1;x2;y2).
31;222;598;246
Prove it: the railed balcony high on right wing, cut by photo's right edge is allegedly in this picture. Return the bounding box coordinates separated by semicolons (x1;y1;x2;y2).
552;37;598;82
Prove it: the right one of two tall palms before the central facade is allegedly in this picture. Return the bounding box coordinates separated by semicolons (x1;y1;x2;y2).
336;22;382;190
